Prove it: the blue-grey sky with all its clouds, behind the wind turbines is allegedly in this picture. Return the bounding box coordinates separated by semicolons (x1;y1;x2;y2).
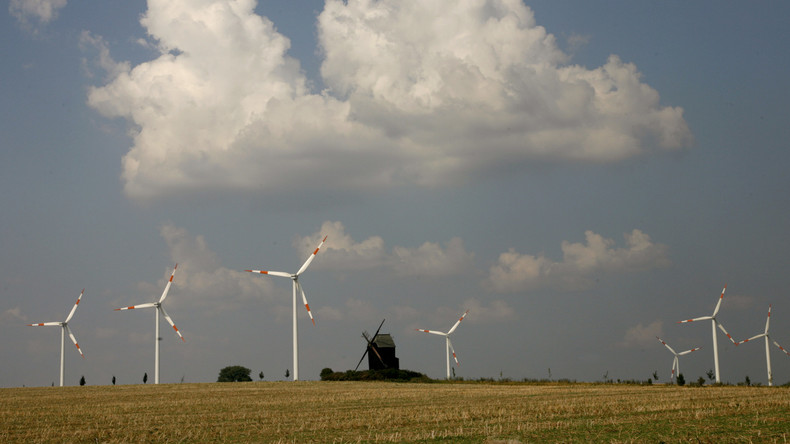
0;0;790;387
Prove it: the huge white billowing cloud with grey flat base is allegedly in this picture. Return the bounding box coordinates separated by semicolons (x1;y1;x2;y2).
88;0;691;198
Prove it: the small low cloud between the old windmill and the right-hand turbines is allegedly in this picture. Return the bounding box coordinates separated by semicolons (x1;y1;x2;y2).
489;230;670;293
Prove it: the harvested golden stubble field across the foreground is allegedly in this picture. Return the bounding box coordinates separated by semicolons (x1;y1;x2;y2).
0;382;790;443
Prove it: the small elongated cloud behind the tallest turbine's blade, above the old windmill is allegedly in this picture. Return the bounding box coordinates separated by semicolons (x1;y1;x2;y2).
294;221;474;276
